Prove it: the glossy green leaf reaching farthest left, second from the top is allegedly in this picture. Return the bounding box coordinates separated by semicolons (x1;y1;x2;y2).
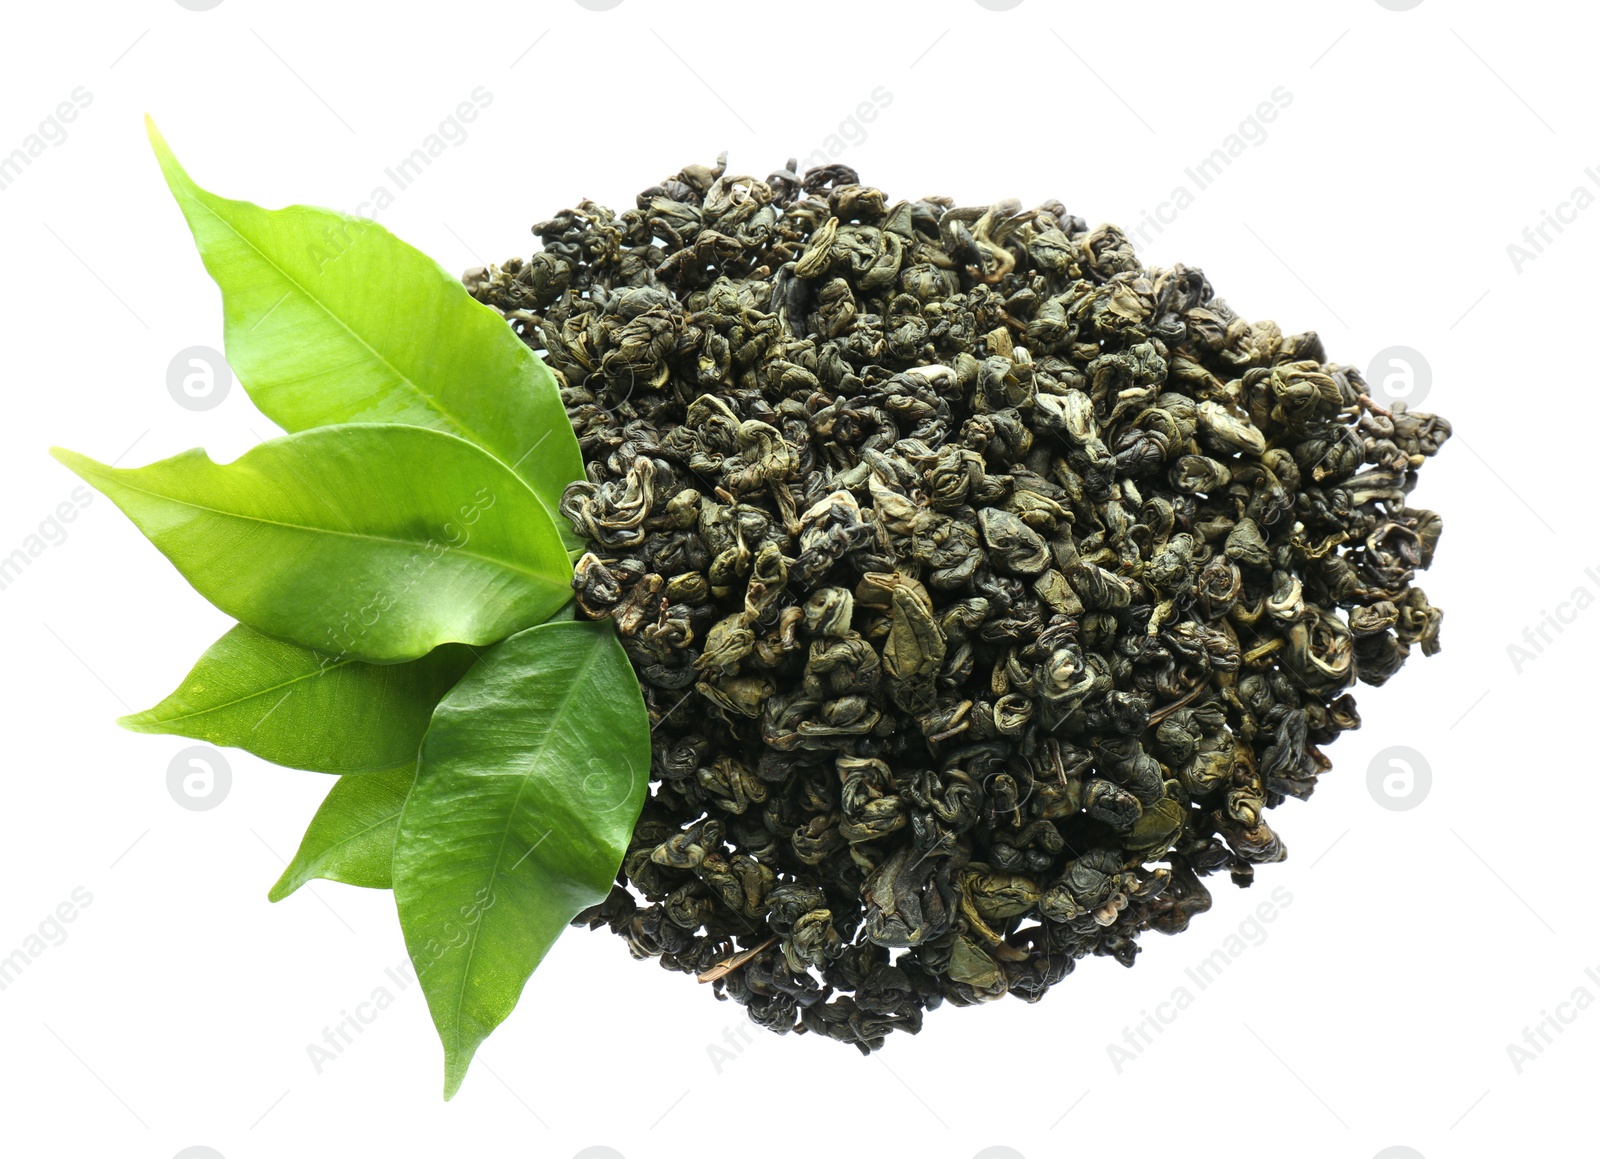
51;424;571;663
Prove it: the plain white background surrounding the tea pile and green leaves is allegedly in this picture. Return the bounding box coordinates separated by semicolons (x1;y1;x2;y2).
0;0;1580;1159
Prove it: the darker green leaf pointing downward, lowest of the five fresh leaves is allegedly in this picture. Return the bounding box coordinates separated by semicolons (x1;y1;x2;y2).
394;623;650;1098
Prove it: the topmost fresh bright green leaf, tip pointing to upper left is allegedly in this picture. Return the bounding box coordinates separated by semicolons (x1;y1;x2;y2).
146;118;584;535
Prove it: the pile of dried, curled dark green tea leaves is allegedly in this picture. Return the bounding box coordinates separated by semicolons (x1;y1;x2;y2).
466;160;1450;1052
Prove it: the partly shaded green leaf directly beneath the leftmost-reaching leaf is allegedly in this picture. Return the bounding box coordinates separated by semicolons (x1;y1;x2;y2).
117;624;477;774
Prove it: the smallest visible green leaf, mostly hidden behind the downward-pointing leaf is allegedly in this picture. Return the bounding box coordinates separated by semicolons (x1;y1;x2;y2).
267;760;416;901
